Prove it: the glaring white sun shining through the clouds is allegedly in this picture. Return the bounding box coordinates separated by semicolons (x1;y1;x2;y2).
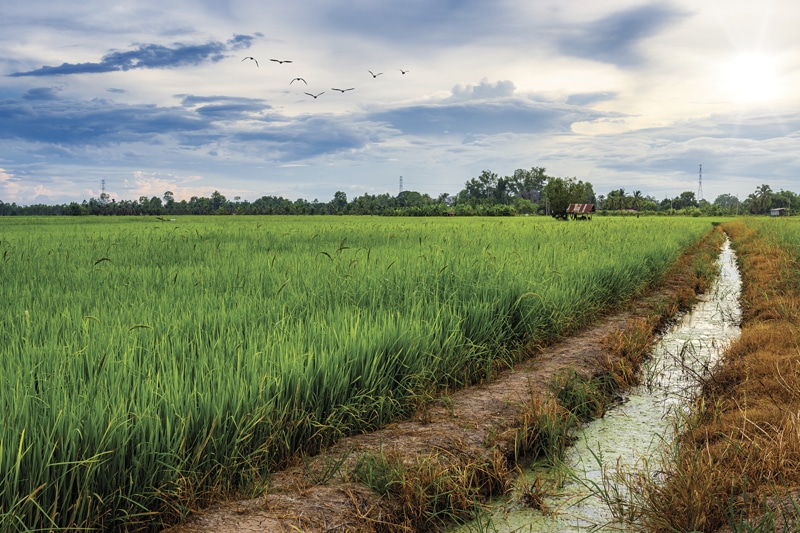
723;53;778;103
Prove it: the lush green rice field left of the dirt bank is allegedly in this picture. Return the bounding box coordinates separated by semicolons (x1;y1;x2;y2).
0;217;711;531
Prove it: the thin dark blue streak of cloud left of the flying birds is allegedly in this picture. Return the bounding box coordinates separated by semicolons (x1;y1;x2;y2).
10;35;255;77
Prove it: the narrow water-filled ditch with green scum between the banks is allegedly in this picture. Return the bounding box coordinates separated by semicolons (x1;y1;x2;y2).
451;241;741;533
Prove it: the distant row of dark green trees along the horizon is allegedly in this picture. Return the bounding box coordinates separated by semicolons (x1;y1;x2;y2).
0;167;800;217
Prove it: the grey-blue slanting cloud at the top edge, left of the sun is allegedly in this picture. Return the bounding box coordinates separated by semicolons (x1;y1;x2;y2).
559;4;687;67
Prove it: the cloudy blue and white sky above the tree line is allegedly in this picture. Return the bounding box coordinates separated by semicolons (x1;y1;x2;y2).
0;0;800;205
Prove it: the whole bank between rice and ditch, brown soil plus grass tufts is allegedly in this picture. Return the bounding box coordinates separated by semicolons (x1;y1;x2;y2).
164;230;722;533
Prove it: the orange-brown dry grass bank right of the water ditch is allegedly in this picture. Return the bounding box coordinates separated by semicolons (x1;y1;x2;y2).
625;221;800;532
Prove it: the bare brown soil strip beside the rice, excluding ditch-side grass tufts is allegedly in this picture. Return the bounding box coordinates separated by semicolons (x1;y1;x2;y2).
167;235;718;533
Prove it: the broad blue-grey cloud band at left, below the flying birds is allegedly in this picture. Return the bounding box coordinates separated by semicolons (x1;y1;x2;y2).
0;88;378;162
